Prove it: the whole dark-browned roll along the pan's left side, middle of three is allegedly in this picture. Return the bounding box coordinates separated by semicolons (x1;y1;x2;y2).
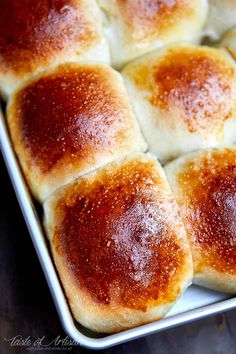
7;63;146;200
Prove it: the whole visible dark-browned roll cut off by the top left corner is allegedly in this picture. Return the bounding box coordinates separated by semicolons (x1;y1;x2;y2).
0;0;109;97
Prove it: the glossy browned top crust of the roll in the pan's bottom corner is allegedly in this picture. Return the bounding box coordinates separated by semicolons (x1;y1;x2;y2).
52;160;189;311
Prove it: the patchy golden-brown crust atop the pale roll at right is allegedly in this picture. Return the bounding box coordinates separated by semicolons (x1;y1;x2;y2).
152;50;236;132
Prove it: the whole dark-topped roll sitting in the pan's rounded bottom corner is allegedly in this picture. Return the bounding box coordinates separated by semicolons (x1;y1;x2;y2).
44;154;192;333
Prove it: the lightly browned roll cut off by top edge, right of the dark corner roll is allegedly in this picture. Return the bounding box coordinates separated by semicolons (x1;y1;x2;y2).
98;0;208;68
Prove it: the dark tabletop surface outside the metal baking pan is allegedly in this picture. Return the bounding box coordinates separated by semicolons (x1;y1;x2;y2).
0;156;236;354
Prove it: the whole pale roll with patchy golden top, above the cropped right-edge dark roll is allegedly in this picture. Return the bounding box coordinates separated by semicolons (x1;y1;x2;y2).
123;43;236;161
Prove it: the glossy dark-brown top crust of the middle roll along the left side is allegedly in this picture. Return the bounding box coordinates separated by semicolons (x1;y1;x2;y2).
10;65;129;173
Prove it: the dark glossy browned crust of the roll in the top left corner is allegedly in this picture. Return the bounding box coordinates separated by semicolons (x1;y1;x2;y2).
0;0;97;75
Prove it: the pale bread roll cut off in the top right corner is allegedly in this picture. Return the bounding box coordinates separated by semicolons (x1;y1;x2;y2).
206;0;236;40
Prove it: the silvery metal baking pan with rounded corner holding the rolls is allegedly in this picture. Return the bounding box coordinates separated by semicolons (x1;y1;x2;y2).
0;111;236;349
